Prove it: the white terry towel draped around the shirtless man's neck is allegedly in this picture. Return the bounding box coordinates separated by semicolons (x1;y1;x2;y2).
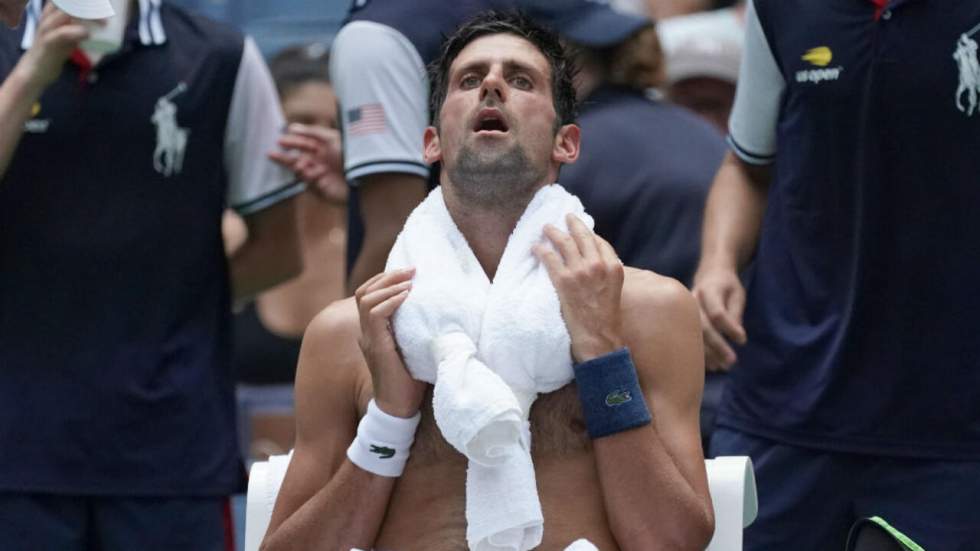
385;184;593;551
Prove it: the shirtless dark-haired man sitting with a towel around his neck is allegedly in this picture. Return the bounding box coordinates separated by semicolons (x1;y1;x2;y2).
263;14;713;551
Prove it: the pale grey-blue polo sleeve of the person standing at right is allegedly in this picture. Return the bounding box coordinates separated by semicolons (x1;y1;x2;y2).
728;0;786;165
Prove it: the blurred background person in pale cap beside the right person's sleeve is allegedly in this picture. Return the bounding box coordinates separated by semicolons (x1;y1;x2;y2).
657;3;745;135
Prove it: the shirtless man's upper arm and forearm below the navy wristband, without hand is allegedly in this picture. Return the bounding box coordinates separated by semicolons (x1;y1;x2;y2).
593;271;714;550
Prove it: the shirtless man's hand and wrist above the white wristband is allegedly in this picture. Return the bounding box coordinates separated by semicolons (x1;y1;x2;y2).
354;268;425;418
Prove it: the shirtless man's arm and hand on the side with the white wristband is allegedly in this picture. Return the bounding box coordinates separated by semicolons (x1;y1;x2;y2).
262;270;425;551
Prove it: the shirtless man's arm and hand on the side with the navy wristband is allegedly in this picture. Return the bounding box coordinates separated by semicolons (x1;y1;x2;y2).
536;216;714;550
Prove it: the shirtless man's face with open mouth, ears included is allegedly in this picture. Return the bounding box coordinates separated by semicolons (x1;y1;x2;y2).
425;34;578;210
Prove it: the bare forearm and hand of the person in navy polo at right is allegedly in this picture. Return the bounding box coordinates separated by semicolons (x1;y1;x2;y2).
694;152;770;370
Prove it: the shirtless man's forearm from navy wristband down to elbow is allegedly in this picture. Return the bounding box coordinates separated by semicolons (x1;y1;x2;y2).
593;424;713;551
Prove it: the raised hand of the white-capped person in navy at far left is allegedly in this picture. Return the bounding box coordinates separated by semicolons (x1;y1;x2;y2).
14;2;88;93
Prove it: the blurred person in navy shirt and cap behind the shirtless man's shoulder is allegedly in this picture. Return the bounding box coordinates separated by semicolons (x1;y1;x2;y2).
556;15;725;452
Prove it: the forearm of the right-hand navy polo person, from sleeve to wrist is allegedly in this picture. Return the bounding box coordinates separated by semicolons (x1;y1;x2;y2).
701;152;769;271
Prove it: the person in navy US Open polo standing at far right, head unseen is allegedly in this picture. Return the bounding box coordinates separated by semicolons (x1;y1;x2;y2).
695;0;980;550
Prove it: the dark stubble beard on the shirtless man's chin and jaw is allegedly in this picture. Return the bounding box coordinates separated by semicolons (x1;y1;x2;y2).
447;138;547;211
